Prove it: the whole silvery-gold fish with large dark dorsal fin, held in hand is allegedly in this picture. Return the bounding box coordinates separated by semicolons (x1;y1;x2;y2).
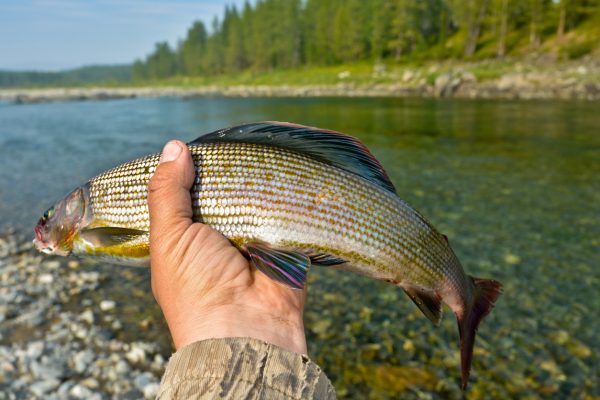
34;121;502;389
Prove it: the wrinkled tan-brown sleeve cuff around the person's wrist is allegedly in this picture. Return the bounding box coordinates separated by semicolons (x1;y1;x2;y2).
158;338;335;400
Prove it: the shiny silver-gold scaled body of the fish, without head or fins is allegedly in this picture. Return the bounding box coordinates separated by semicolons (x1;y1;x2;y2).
89;143;445;287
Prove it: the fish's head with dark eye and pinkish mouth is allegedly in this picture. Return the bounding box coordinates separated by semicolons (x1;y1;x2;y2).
33;187;90;256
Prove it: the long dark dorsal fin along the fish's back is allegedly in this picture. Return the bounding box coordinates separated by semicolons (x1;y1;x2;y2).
189;121;396;193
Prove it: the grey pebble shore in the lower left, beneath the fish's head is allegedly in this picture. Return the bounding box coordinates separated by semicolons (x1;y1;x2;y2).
0;228;169;399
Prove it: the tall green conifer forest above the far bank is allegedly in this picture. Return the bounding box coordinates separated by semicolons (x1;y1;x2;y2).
133;0;600;79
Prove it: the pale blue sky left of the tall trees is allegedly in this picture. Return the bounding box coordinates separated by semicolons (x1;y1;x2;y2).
0;0;244;71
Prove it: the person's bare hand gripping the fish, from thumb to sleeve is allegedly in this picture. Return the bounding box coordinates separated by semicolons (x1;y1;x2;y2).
148;141;306;353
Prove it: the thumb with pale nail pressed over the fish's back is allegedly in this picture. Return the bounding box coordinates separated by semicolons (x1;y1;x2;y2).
148;140;195;252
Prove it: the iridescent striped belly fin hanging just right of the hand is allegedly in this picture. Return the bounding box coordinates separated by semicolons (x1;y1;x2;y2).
246;243;310;289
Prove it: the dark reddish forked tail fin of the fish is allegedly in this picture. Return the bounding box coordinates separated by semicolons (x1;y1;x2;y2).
456;277;502;390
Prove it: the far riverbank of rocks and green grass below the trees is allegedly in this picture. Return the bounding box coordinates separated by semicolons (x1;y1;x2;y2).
0;58;600;104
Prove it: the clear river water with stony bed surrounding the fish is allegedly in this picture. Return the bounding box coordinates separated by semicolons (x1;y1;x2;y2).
0;98;600;398
